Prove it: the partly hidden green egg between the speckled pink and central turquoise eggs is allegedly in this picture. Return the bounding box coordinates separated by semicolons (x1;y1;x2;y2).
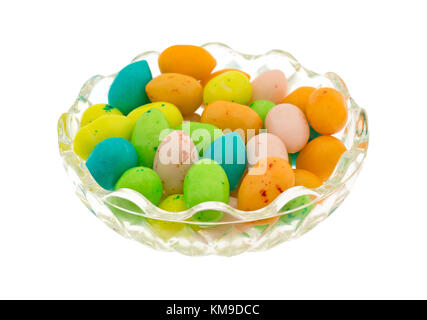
176;121;222;156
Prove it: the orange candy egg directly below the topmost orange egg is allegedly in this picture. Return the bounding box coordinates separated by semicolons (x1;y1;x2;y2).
146;73;203;115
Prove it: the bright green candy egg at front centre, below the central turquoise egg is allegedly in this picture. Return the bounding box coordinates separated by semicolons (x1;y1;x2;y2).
184;159;230;222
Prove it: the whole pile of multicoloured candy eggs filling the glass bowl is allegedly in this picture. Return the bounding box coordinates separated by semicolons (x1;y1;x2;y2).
73;45;348;222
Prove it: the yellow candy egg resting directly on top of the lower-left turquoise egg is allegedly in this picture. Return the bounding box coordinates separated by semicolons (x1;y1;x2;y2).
73;115;133;160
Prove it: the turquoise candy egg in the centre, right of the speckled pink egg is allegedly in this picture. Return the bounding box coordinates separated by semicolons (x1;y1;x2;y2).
203;132;246;191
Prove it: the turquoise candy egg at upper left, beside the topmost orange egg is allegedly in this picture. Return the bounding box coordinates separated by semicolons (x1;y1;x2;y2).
108;60;153;115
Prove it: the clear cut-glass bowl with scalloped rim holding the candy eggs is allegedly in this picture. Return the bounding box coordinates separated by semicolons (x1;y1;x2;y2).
58;43;369;256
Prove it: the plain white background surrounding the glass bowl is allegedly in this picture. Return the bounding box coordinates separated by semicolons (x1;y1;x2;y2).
0;0;427;299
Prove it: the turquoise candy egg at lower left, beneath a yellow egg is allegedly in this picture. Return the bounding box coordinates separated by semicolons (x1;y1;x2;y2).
86;137;137;190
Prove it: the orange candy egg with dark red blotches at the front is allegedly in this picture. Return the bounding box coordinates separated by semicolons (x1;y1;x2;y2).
237;157;295;211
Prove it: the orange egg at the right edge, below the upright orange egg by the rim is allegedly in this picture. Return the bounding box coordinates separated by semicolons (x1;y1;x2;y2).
296;136;347;181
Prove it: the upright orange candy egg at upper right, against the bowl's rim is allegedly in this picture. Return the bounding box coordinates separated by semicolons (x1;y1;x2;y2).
305;88;347;135
